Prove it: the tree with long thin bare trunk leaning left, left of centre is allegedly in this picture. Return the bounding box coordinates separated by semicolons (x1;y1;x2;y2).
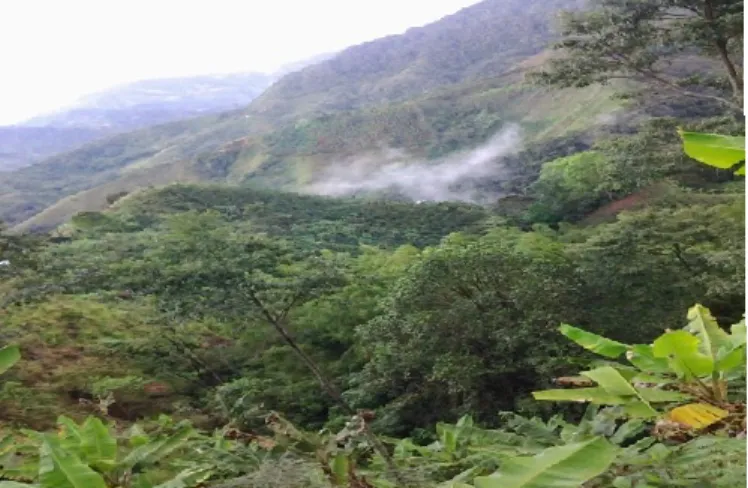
125;212;400;480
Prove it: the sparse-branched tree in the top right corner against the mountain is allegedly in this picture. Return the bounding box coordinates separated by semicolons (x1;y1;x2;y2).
534;0;743;111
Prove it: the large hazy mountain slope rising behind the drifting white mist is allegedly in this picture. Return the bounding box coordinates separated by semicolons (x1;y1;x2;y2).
0;0;618;229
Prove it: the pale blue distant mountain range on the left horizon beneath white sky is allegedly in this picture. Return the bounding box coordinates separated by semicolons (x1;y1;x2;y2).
0;54;332;171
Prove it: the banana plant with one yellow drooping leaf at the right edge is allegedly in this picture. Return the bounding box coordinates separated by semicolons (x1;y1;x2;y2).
533;304;746;429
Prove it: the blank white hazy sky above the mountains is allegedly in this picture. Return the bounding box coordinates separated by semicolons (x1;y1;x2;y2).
0;0;478;124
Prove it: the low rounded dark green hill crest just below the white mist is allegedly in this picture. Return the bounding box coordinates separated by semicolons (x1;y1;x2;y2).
59;184;491;253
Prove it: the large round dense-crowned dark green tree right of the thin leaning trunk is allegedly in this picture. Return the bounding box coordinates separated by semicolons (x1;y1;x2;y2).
347;228;579;432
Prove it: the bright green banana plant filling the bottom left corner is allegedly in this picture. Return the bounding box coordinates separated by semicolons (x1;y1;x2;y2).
0;416;211;488
